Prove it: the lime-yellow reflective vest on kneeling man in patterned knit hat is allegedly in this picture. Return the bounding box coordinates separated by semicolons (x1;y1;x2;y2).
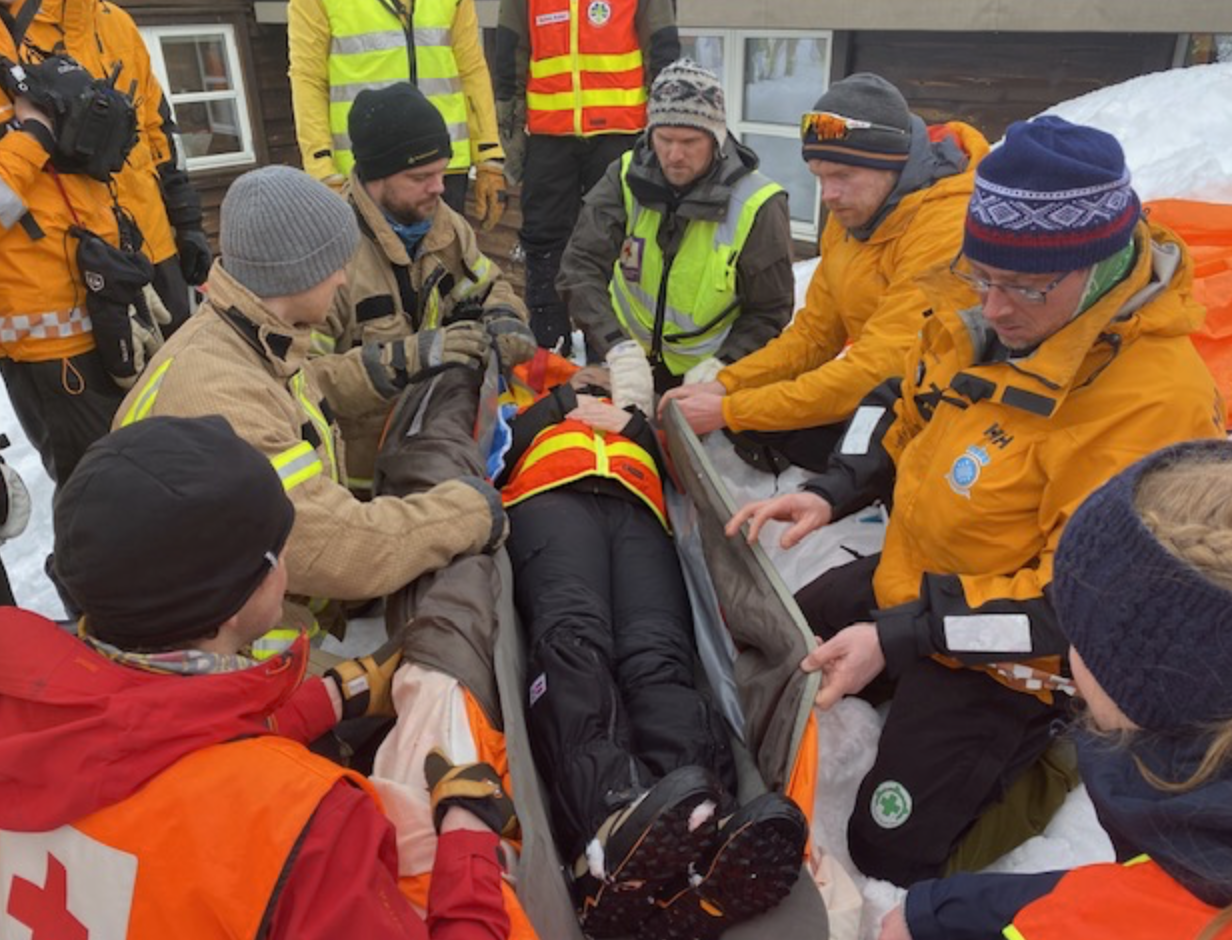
609;152;782;376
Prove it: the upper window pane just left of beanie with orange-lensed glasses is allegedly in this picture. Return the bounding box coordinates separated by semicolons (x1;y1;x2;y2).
744;37;829;127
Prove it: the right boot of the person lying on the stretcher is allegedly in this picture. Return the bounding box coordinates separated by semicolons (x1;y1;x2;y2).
637;793;808;940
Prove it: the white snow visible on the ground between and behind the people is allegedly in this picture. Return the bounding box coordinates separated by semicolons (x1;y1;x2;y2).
0;63;1232;940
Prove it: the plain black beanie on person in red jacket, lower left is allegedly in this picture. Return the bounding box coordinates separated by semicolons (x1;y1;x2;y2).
54;415;294;650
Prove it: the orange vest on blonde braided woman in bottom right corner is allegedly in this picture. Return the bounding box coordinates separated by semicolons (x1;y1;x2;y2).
1002;855;1232;940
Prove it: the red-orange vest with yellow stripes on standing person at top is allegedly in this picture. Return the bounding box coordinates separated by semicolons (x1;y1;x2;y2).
526;0;647;137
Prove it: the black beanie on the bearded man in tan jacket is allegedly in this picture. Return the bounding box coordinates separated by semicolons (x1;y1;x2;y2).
346;81;453;180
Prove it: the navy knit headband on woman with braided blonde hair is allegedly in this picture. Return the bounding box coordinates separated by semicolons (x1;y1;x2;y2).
1051;440;1232;732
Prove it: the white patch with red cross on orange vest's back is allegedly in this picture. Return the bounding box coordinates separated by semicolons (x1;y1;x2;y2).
0;825;137;940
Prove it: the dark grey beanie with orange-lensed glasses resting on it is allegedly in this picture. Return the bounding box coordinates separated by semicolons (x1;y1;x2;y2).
801;71;912;170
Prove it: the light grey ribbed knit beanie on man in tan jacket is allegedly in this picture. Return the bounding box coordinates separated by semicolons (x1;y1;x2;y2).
219;165;360;297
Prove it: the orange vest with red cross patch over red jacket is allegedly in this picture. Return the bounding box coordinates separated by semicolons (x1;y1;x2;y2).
0;735;381;940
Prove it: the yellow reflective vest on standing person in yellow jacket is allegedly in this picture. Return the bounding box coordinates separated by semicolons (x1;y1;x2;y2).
324;0;471;176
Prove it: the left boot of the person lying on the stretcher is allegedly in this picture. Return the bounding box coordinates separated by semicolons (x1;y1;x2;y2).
573;766;719;938
